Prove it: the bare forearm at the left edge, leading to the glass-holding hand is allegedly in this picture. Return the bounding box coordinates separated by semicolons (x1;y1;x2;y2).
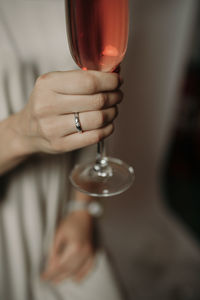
0;114;30;176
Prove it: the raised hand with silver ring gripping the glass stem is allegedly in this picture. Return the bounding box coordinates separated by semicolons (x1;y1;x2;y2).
18;71;122;154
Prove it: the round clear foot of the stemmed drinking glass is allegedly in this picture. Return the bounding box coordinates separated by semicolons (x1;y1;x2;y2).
70;157;135;197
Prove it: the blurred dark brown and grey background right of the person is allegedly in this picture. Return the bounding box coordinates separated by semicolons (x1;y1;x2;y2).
100;0;200;300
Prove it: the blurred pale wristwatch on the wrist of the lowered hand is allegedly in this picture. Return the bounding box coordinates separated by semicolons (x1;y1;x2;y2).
67;200;103;218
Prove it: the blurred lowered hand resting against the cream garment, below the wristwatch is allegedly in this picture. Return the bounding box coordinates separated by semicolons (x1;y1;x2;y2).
42;211;94;283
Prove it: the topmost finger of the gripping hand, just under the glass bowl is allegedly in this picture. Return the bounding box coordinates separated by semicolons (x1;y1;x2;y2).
37;70;121;95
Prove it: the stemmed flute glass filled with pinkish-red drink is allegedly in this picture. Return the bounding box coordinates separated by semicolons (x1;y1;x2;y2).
65;0;134;197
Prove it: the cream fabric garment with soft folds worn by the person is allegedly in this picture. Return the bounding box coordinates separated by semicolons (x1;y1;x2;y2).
0;0;120;300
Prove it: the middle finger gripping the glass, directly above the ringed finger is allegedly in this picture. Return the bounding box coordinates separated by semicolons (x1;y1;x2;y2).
52;90;123;114
